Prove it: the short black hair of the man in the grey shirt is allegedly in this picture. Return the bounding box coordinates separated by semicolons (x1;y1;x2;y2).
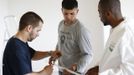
62;0;78;10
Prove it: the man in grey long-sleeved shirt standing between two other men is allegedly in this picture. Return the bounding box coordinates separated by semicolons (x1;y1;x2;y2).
50;0;92;75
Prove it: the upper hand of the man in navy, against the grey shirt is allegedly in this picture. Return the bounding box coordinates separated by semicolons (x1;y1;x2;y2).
49;50;61;64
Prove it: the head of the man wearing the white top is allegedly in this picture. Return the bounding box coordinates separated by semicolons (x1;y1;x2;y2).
98;0;123;27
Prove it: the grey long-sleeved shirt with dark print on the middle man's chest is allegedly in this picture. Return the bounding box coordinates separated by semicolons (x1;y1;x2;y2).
57;20;92;73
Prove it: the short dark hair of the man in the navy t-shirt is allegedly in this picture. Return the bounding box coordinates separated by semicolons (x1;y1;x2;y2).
19;11;43;31
